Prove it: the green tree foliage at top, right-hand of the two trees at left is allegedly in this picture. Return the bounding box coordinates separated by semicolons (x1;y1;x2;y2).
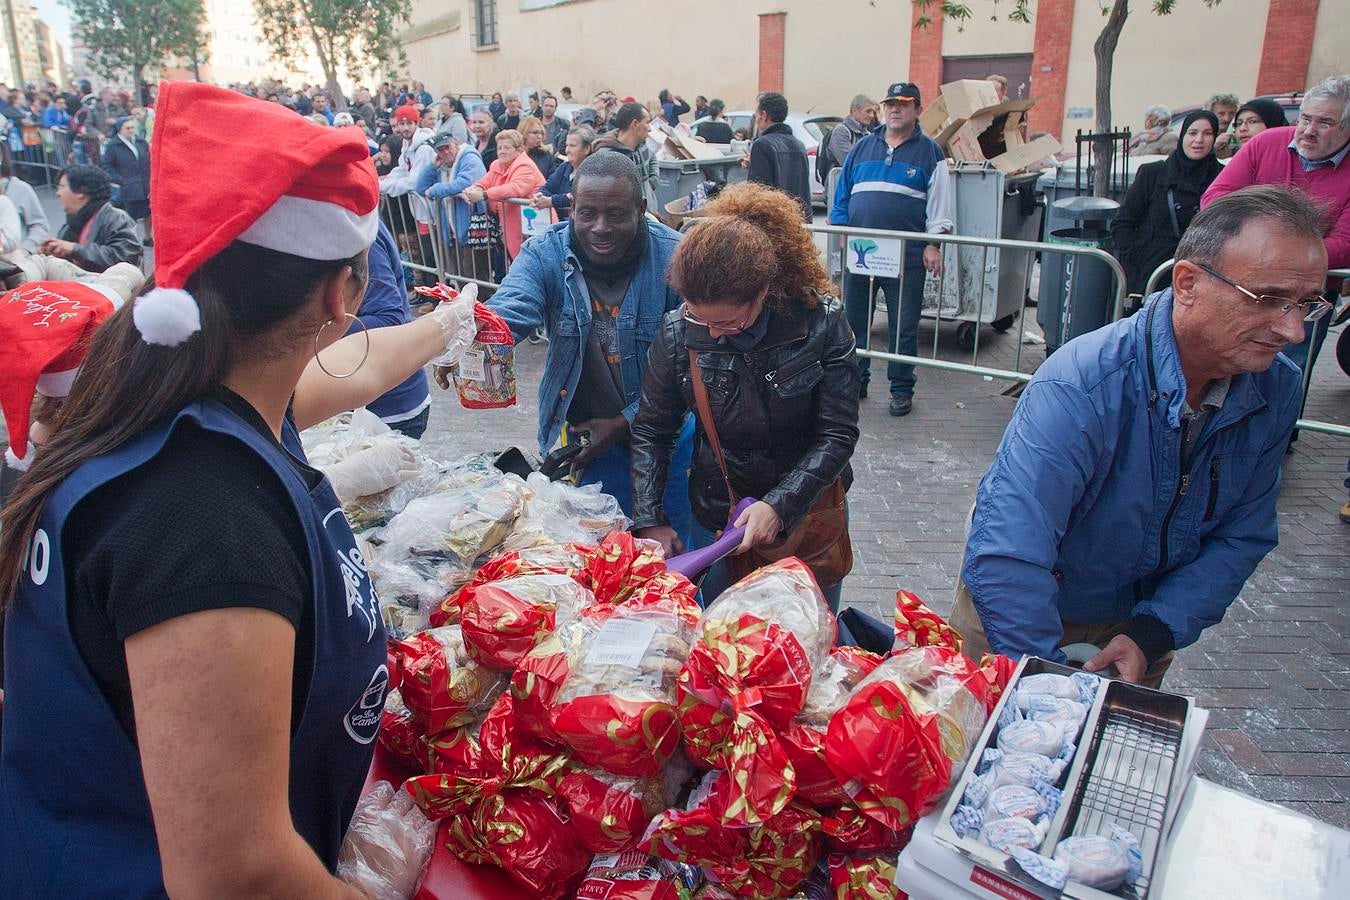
254;0;412;109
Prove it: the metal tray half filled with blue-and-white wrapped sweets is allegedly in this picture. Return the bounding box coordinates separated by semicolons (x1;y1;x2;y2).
934;657;1192;900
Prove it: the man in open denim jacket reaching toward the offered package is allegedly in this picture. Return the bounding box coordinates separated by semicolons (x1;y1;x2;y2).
437;152;705;546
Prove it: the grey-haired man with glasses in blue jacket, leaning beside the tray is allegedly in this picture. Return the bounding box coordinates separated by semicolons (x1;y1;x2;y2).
952;186;1330;687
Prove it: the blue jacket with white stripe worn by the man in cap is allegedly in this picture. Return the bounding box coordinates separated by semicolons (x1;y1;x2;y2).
830;127;953;267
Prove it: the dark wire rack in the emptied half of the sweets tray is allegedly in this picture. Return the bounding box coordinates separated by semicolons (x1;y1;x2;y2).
1065;701;1185;897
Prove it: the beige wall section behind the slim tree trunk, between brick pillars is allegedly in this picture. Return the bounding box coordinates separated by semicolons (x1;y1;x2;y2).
1058;0;1269;148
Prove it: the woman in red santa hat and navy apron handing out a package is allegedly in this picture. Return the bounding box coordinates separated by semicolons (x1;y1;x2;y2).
0;82;471;897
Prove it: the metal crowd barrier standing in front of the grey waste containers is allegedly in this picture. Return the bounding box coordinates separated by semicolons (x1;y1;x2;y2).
803;224;1125;382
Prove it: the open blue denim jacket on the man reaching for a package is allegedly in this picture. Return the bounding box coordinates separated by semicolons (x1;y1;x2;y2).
487;220;680;453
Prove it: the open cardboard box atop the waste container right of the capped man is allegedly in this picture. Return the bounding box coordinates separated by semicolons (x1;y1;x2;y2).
919;78;1060;174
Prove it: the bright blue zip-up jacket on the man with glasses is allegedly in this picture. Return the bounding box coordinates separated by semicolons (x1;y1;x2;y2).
961;289;1303;663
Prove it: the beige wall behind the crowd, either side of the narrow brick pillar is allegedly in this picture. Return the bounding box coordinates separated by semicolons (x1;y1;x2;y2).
405;0;910;112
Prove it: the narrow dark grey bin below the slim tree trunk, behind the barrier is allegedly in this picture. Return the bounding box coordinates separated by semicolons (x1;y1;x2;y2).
1035;197;1121;355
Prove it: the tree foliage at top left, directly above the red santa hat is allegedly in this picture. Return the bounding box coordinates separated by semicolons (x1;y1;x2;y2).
65;0;205;103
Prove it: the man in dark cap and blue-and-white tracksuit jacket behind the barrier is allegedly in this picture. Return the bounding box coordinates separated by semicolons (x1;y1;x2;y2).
830;82;956;416
